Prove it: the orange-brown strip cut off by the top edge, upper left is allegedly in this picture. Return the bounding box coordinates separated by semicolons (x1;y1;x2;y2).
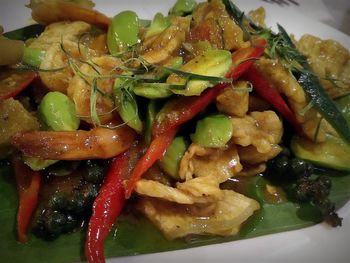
29;0;111;29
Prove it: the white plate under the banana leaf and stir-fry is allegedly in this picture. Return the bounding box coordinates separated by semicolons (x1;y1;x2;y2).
0;0;350;263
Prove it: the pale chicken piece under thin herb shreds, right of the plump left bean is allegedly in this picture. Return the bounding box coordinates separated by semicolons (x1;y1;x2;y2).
67;56;122;124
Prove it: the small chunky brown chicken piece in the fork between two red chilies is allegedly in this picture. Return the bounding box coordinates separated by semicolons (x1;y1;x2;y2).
216;81;249;117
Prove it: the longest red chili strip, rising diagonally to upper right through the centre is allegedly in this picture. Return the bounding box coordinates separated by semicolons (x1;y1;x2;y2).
125;39;266;198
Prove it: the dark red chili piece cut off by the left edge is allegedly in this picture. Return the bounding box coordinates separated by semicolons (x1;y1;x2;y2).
0;69;37;101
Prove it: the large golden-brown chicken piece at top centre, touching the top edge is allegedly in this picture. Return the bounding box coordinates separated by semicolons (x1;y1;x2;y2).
189;0;250;50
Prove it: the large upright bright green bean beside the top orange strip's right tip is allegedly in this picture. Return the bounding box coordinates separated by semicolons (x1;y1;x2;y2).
107;11;140;54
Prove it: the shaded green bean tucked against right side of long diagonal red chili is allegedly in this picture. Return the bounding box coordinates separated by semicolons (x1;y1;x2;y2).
158;136;188;179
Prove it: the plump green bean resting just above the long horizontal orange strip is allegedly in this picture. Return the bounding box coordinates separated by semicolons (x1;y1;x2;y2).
38;91;80;131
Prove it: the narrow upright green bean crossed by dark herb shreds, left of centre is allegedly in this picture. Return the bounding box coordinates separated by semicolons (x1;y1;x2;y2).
113;78;143;133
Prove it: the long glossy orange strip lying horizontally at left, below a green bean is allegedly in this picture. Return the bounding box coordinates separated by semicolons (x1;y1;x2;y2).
11;125;136;160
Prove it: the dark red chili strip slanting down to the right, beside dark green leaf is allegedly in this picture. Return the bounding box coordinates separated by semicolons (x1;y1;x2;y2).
243;65;301;133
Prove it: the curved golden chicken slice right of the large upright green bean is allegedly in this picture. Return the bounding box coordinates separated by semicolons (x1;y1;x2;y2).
142;17;190;64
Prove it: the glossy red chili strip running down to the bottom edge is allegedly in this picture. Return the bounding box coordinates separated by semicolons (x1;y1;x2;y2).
85;152;128;263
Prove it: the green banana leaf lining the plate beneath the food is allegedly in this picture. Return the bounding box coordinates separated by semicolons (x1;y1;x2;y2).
0;162;350;263
